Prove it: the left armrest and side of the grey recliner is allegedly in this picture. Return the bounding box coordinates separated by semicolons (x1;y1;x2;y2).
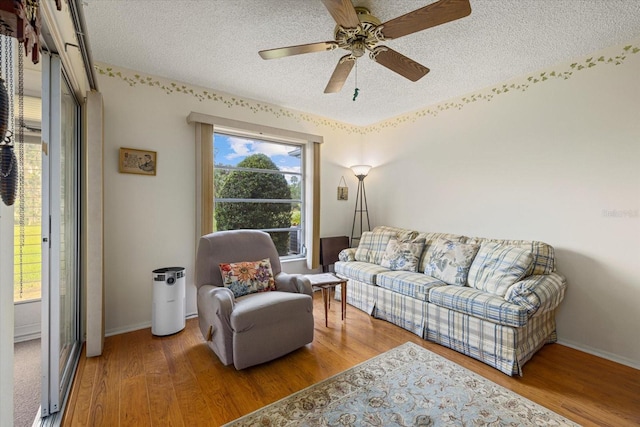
198;285;235;365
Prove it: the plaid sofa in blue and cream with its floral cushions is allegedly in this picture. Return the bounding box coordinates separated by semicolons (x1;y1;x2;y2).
335;226;566;375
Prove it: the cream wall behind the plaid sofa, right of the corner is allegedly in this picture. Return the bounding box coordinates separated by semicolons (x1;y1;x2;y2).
364;39;640;367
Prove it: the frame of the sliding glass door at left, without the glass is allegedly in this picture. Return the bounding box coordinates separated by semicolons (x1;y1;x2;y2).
40;52;81;418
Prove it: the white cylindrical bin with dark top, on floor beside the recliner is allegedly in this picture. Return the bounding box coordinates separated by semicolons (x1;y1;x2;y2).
151;267;186;336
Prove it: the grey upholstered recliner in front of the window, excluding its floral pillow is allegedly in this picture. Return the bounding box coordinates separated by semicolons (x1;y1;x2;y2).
195;230;314;369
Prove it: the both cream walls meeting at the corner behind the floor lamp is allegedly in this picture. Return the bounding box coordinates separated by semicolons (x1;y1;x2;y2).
99;38;640;367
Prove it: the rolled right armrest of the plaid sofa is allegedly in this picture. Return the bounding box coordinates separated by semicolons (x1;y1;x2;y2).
504;273;567;317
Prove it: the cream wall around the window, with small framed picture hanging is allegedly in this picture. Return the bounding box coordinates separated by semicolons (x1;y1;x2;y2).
98;66;361;334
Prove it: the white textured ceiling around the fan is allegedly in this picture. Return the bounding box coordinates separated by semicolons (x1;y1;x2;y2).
83;0;640;125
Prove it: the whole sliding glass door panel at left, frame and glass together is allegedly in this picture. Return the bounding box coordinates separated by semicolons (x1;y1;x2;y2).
41;54;80;417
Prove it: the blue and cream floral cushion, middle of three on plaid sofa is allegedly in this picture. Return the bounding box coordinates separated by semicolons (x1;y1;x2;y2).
424;239;480;286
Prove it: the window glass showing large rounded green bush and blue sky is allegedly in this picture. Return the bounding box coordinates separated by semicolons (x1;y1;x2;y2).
213;132;305;257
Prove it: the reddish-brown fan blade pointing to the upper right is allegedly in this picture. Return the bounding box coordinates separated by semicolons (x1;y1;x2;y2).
382;0;471;39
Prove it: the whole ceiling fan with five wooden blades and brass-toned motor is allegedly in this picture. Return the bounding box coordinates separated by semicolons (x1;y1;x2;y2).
258;0;471;93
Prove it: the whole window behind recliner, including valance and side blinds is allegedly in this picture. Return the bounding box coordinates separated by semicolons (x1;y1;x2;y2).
187;112;322;269
